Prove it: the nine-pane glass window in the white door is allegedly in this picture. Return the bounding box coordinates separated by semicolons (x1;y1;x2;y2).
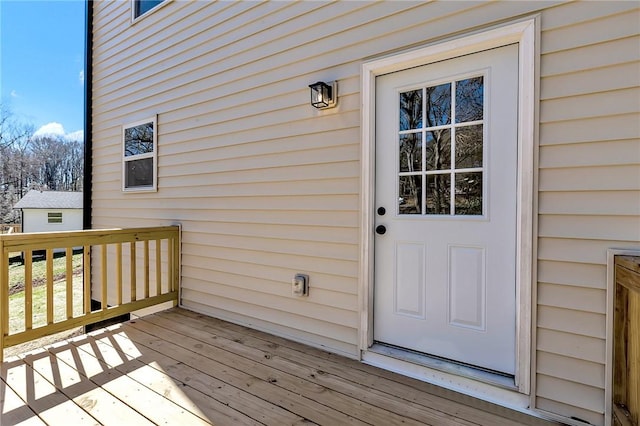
397;76;485;216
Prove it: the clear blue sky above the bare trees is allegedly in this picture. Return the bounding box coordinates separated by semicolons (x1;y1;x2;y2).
0;0;85;138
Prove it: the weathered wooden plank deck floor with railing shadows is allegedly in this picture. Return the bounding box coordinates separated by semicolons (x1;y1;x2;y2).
0;309;550;426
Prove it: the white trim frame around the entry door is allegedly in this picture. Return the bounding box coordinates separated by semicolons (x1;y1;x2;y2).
359;18;537;394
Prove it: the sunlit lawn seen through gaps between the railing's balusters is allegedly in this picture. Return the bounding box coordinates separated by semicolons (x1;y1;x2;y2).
9;254;83;333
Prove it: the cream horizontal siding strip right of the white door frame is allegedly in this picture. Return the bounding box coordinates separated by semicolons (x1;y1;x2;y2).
535;2;640;424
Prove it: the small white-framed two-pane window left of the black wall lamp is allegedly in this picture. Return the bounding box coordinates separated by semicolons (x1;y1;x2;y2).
122;116;158;192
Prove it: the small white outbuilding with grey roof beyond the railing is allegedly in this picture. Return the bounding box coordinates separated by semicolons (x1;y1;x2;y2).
13;189;82;232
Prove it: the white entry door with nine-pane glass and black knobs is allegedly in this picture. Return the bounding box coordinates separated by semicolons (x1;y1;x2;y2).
374;45;518;375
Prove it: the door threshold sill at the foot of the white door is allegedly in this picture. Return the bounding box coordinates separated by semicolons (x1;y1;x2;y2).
368;342;518;391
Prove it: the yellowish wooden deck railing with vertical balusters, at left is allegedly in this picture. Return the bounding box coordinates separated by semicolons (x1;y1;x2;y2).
0;226;180;362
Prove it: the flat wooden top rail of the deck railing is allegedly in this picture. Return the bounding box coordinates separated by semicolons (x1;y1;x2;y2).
0;226;180;252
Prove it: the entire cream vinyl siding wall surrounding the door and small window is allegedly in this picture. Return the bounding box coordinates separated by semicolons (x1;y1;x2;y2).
92;1;640;424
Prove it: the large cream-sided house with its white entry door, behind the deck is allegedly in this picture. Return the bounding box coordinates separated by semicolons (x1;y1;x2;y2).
85;0;640;425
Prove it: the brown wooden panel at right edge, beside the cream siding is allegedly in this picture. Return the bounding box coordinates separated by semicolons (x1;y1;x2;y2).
613;256;640;426
